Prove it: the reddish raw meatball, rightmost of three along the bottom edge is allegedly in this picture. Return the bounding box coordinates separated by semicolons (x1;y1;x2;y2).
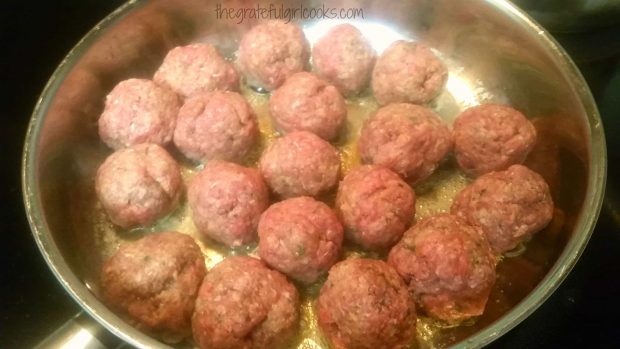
318;258;416;349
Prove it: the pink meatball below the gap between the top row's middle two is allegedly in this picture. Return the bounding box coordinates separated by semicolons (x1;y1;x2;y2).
269;72;347;140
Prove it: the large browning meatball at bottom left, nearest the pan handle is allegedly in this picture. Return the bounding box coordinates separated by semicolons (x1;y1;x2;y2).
100;232;206;342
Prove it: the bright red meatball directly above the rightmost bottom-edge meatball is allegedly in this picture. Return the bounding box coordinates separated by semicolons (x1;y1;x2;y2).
336;165;415;250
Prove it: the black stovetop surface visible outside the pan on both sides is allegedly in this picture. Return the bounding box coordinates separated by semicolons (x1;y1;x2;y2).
0;0;620;348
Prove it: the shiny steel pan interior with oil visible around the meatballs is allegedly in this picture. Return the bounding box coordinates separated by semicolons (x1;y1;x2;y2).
23;0;606;348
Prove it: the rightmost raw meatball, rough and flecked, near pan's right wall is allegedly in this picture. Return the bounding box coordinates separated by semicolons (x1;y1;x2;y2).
451;165;553;253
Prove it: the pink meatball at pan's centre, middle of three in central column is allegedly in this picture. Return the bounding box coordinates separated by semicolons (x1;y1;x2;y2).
259;131;340;197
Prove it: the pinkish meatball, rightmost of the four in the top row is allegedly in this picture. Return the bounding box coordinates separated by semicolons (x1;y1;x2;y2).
372;41;448;105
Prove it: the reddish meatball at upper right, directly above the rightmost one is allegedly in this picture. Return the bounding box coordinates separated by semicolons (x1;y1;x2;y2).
453;104;536;176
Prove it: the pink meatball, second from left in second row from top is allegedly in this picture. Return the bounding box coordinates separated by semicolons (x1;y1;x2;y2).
174;91;259;161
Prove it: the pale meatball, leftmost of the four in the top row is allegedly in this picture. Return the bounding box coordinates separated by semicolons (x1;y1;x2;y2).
153;44;239;98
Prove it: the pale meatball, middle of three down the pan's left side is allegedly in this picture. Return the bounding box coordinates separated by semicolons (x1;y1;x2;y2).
95;143;183;228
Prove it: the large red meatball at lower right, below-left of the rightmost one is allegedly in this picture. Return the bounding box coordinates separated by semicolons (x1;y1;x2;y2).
388;214;496;322
